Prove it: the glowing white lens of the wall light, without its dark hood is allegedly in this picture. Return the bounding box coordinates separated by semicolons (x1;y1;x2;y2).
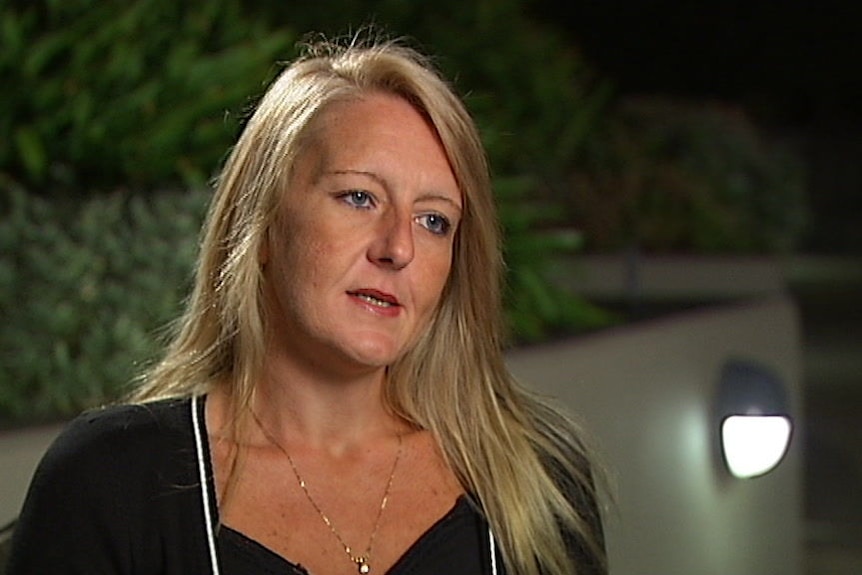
721;415;792;478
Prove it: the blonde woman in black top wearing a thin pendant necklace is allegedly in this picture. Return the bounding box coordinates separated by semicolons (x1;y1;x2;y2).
10;38;605;575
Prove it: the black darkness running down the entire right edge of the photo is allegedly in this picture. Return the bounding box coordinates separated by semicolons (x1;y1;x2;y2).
534;0;862;575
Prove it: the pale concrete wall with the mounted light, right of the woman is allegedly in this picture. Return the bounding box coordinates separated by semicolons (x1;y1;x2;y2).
510;298;802;575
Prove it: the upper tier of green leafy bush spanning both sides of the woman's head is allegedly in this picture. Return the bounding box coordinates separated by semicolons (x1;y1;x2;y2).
0;0;606;195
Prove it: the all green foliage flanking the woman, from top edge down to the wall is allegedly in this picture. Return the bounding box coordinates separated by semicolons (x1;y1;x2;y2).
0;0;606;419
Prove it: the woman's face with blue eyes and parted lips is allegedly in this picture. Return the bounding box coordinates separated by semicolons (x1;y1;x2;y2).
261;94;462;371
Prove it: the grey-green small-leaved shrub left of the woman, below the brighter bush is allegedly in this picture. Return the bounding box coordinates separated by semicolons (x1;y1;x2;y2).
0;189;208;419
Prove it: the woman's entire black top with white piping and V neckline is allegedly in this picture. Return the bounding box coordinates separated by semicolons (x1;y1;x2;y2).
7;399;604;575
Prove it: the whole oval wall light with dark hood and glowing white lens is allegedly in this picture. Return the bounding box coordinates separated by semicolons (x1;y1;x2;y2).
716;360;793;477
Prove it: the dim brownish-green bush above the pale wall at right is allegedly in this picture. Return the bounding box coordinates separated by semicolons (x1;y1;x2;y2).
567;98;805;254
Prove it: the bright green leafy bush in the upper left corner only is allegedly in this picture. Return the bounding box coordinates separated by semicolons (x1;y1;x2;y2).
0;0;295;194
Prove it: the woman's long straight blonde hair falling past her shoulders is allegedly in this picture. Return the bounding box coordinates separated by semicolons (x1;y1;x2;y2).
134;35;605;575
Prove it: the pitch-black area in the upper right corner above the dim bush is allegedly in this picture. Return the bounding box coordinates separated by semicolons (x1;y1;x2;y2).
533;0;862;255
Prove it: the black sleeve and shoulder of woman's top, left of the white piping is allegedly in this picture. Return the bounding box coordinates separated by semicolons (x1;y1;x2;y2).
7;400;218;575
